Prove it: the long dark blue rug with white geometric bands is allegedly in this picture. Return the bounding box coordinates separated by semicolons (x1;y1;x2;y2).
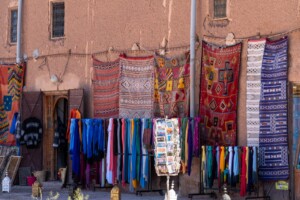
258;37;289;180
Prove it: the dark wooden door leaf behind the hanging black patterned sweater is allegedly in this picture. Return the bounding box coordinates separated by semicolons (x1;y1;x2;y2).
20;92;44;171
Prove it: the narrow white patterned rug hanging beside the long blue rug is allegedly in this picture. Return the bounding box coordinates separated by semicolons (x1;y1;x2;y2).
246;39;266;146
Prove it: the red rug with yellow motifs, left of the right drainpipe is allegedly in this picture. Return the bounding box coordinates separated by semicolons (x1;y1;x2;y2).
154;54;190;117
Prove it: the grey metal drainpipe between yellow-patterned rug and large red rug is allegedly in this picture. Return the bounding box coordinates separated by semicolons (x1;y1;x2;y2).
190;0;196;117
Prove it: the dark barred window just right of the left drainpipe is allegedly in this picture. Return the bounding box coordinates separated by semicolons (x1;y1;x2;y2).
52;2;65;38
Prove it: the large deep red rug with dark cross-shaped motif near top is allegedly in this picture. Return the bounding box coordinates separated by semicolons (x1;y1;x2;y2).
200;41;242;146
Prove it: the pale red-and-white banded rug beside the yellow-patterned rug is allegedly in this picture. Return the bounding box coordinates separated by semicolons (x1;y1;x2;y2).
119;55;154;118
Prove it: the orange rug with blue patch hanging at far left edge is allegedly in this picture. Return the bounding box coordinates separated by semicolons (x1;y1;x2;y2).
0;64;25;146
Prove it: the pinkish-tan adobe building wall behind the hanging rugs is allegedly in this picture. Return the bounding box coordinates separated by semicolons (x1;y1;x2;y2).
0;0;300;199
